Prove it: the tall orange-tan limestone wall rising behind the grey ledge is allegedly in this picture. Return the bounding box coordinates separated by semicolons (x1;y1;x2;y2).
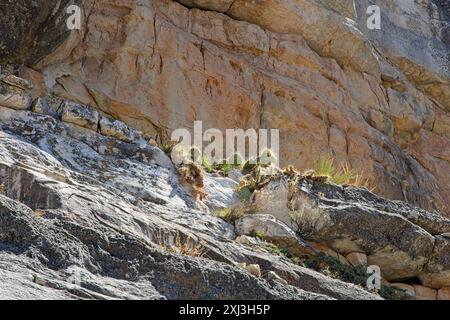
11;0;450;214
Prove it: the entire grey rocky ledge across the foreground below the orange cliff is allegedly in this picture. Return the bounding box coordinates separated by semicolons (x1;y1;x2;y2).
0;75;450;299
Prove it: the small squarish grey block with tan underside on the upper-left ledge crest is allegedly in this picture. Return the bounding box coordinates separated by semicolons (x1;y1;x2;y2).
61;101;99;131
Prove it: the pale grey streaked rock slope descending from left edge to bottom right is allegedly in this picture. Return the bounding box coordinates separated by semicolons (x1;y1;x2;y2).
0;104;379;299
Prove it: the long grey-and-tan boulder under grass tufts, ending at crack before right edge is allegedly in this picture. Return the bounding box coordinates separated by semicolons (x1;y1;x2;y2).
249;174;436;281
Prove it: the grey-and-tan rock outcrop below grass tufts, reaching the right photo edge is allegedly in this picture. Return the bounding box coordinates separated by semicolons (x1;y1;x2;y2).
238;173;450;296
